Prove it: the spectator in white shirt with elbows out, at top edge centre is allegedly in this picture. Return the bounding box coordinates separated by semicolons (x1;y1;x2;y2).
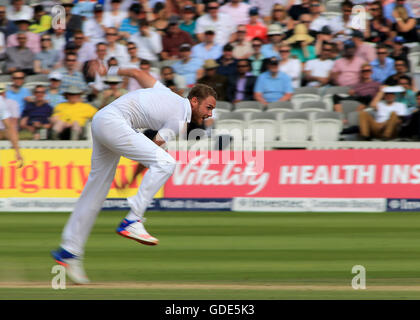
195;0;236;46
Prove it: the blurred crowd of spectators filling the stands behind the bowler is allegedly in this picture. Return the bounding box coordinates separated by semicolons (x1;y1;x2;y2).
0;0;420;140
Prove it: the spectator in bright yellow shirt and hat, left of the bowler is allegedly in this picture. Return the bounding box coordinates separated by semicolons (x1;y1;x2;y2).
51;86;98;140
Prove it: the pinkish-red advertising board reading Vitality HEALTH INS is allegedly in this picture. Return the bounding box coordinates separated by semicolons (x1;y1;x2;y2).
164;149;420;198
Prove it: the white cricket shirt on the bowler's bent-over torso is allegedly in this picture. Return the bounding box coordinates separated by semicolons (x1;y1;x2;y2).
106;81;191;142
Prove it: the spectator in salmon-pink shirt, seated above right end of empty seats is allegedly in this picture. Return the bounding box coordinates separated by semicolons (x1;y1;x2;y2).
330;40;365;86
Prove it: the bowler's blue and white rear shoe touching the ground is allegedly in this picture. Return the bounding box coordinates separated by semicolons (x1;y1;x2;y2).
51;247;90;284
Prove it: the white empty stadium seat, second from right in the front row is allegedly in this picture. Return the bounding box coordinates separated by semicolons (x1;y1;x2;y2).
280;111;310;142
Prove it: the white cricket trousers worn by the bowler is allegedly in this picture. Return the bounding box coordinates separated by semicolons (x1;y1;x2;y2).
61;106;176;256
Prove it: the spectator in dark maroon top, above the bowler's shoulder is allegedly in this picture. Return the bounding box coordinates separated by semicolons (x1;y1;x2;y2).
161;17;193;60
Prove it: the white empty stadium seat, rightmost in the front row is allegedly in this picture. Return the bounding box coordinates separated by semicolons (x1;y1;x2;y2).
311;111;343;141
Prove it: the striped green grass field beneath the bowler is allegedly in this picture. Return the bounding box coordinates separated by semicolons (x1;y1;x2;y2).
0;211;420;300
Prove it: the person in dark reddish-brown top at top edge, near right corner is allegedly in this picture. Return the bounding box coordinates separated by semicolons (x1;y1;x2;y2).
366;1;392;43
